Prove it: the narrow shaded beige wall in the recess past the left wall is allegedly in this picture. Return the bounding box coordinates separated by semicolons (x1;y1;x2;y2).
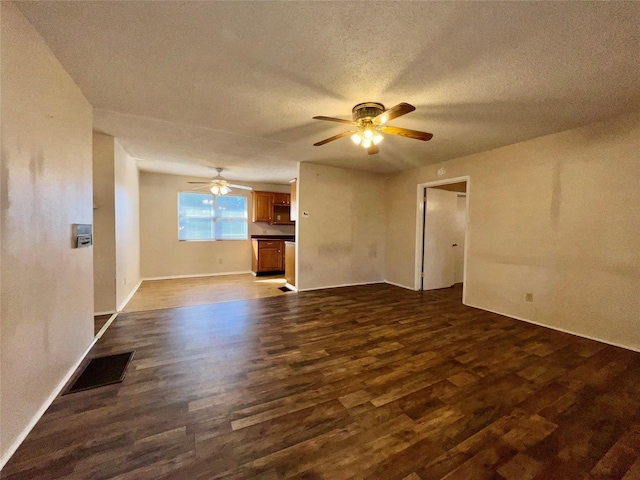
93;132;117;313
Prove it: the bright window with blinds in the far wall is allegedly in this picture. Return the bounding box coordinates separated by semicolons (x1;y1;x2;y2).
178;192;248;240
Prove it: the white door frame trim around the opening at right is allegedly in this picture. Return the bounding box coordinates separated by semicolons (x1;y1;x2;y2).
413;175;471;303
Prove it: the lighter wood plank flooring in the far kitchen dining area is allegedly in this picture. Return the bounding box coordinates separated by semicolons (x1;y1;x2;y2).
124;273;286;312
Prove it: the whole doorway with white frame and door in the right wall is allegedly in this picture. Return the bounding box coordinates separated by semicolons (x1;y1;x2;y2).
415;176;470;303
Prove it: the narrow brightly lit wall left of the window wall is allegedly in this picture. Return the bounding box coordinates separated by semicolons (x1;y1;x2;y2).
113;140;140;310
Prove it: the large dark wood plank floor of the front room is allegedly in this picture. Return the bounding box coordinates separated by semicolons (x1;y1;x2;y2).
2;285;640;480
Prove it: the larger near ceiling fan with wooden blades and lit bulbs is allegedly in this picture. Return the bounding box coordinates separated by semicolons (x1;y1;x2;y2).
313;102;433;155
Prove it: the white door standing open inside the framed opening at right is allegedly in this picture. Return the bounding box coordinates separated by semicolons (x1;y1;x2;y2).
422;188;458;290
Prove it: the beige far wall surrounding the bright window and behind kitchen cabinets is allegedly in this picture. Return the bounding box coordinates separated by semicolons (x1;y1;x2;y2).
140;172;294;278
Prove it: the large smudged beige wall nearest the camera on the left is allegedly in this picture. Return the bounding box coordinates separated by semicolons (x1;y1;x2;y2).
0;2;93;465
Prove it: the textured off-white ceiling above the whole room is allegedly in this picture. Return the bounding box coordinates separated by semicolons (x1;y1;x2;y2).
18;1;640;182
